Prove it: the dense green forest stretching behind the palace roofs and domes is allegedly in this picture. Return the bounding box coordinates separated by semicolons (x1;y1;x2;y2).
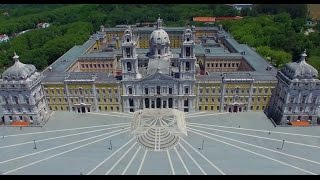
0;4;320;72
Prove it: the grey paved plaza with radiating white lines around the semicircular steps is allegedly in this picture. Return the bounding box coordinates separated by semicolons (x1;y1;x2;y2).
0;111;320;175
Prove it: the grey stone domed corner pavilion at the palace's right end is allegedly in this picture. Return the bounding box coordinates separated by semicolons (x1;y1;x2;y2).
267;51;320;125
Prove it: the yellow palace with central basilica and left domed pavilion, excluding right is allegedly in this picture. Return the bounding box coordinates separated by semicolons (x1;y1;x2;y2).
0;18;306;124
